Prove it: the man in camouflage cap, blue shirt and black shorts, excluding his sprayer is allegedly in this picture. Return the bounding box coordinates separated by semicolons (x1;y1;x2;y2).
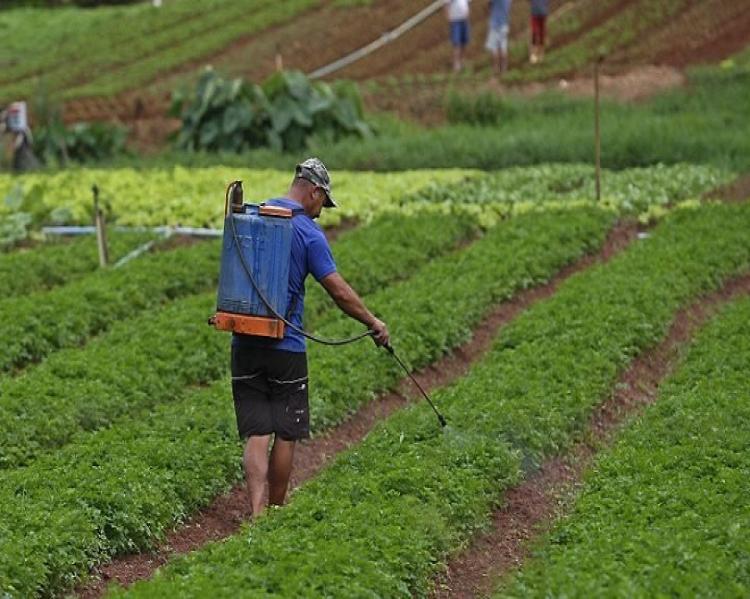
231;158;390;517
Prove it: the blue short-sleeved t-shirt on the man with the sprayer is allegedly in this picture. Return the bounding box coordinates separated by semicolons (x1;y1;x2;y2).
232;198;336;353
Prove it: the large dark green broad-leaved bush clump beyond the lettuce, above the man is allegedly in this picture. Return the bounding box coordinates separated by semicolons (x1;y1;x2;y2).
171;69;370;152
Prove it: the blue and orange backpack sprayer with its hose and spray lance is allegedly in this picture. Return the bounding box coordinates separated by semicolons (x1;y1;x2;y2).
208;181;446;427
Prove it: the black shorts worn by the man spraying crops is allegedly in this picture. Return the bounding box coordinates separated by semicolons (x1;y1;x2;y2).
232;345;310;441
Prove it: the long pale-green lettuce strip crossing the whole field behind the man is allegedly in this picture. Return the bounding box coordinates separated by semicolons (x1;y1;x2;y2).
0;164;734;234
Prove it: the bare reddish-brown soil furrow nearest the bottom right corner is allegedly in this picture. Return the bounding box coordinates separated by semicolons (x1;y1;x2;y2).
432;276;750;599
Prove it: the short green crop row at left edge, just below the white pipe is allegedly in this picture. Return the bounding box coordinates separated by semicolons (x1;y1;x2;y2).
0;232;153;301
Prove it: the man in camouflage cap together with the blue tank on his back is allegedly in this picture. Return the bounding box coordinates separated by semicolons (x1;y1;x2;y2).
209;158;390;517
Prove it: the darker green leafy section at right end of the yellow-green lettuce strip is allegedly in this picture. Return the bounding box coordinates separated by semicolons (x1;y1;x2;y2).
408;164;734;225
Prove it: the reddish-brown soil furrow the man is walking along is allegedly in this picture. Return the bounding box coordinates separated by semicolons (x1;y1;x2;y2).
77;223;638;599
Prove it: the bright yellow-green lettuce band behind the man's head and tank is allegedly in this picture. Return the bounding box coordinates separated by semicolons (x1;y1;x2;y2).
0;171;469;228
